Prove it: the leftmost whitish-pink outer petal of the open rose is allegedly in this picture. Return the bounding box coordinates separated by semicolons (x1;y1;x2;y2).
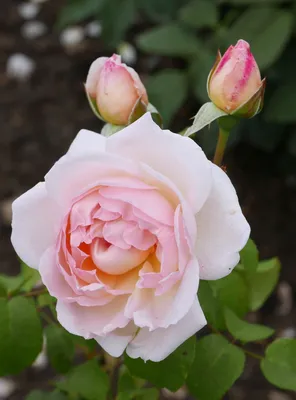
11;183;61;269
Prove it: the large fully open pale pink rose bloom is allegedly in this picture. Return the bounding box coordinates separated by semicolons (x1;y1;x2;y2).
12;113;250;361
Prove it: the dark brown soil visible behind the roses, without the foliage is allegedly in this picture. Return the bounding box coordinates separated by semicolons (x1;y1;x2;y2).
0;0;296;400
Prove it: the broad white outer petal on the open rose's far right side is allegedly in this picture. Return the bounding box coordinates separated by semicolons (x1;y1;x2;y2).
195;164;250;279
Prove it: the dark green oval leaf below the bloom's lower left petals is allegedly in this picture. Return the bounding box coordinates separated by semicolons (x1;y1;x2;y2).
45;325;75;374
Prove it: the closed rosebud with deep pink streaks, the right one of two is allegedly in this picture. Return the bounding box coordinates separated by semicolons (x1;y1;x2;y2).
208;40;265;118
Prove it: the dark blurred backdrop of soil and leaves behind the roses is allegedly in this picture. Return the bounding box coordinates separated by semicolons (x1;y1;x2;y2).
0;0;296;400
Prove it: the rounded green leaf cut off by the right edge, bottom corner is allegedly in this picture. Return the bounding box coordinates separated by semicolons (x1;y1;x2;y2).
261;339;296;391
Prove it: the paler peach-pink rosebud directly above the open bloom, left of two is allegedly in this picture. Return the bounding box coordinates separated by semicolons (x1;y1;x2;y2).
85;54;148;125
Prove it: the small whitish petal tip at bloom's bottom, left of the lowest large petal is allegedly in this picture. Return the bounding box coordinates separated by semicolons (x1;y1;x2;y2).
95;322;137;357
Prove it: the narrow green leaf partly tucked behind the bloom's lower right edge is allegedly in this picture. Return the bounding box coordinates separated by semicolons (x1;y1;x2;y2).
198;281;225;329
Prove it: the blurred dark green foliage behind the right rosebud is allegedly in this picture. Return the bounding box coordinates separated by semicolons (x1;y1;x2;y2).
59;0;296;168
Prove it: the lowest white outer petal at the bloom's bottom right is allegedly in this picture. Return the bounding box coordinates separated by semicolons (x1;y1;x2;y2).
126;298;206;362
